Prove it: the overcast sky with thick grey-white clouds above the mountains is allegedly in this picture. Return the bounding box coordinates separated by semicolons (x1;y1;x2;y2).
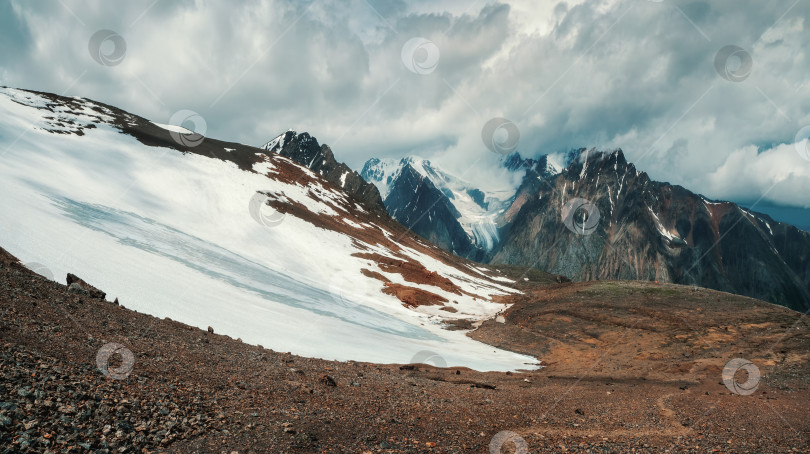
0;0;810;226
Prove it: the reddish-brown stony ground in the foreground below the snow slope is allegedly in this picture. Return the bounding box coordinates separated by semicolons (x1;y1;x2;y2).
0;249;810;453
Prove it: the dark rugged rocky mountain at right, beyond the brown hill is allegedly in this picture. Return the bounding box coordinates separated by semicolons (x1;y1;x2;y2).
491;150;810;311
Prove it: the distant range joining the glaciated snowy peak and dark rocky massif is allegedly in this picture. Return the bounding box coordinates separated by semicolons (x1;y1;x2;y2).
361;149;810;311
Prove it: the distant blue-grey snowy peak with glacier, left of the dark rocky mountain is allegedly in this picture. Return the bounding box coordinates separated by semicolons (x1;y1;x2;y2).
361;156;512;260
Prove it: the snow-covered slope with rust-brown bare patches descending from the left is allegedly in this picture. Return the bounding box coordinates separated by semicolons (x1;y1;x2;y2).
0;88;537;370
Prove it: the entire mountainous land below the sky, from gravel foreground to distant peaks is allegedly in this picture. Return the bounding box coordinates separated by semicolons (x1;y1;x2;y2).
0;87;810;452
